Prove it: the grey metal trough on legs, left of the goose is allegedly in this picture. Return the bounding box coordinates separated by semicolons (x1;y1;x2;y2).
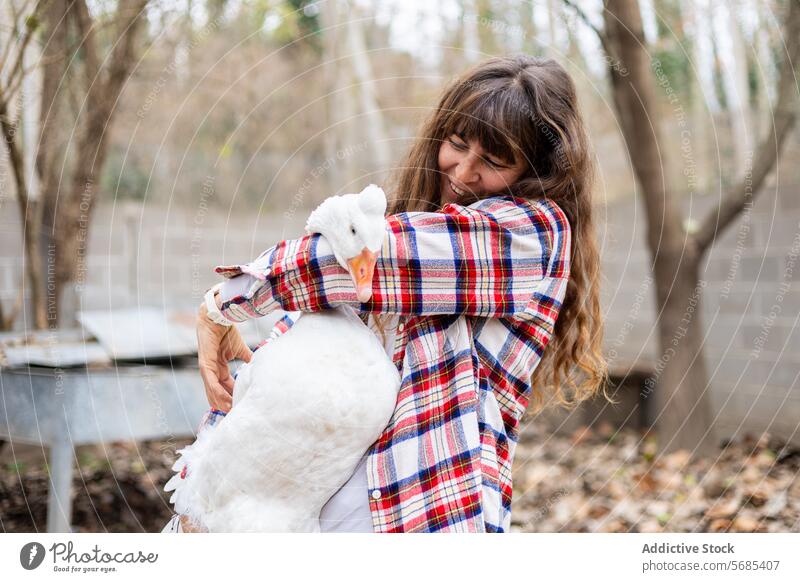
0;308;279;532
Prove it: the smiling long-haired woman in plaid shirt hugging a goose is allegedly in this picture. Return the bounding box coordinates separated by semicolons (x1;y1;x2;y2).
181;56;605;532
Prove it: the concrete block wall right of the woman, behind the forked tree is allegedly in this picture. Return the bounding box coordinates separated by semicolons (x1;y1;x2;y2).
600;184;800;444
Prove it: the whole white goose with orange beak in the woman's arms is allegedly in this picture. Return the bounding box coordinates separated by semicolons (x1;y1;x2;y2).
165;185;400;532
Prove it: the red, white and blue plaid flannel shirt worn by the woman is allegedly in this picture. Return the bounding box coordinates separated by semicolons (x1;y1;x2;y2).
216;197;571;532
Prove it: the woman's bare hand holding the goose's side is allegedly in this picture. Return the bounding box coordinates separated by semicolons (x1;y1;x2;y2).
197;304;253;412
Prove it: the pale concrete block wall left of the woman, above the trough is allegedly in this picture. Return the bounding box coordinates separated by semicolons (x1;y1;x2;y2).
0;203;305;329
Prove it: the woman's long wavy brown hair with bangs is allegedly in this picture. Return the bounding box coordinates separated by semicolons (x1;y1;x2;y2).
390;55;607;411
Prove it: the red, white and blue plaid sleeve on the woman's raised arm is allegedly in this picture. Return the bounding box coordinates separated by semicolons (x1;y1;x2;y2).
216;198;570;330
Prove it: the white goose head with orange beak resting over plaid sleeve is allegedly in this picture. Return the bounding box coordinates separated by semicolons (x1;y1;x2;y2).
306;184;386;303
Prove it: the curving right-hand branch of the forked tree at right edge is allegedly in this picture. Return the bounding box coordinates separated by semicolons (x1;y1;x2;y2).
694;0;800;254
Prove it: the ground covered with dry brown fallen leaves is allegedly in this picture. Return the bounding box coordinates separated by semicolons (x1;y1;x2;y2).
0;424;800;532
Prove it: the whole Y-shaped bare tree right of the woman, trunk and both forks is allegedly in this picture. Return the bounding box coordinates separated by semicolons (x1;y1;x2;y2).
598;0;800;454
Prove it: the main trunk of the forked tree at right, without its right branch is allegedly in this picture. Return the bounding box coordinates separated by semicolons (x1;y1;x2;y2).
604;0;713;454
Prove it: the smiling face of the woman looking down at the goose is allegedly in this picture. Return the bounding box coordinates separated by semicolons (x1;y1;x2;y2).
439;135;525;206
